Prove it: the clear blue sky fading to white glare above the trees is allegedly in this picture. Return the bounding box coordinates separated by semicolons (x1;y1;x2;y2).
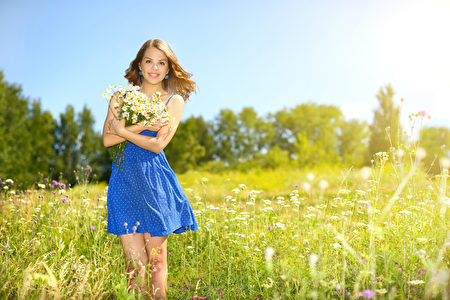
0;0;450;132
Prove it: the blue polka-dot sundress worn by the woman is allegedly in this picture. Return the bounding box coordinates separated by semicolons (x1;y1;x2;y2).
107;95;198;236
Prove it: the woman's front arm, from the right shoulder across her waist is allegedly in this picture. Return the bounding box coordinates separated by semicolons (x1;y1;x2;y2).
111;95;184;153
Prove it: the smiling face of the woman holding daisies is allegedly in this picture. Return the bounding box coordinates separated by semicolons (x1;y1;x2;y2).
139;47;169;84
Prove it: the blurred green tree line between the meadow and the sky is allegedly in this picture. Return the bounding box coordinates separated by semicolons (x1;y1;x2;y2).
0;72;450;188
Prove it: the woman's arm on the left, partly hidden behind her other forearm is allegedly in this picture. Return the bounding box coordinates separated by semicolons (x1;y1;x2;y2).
103;93;169;147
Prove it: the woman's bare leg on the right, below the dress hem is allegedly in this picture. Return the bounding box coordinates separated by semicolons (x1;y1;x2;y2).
144;233;168;300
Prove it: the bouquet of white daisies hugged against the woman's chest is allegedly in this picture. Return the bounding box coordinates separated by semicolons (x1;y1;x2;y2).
103;85;169;167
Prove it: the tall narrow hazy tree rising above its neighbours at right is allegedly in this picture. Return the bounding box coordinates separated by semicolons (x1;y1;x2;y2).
368;84;402;160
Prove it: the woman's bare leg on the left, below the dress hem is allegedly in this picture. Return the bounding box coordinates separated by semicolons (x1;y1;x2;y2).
120;233;148;294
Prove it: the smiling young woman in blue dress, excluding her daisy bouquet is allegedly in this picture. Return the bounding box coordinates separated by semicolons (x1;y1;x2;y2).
103;39;198;299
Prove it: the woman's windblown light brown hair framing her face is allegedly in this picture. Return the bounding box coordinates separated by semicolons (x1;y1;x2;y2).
125;39;197;101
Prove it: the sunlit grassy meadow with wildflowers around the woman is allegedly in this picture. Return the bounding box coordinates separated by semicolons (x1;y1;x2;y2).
0;151;450;299
